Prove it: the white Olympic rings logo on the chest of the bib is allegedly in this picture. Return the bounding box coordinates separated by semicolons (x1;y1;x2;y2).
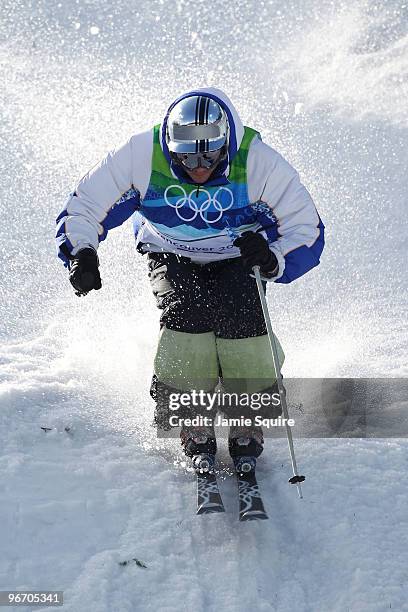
164;185;234;223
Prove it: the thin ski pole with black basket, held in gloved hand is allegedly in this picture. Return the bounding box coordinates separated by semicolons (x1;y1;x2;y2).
252;266;305;499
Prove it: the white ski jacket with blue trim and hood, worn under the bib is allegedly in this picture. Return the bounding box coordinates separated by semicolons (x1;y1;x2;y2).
56;88;324;283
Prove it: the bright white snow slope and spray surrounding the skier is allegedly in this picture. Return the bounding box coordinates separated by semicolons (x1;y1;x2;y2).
0;0;408;612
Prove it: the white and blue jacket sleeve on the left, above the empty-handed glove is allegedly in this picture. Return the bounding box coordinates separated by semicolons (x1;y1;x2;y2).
56;131;153;266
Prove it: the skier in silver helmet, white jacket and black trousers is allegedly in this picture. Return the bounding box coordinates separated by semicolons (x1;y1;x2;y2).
56;88;324;478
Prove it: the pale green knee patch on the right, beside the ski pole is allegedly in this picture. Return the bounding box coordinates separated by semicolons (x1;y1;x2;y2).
216;334;285;393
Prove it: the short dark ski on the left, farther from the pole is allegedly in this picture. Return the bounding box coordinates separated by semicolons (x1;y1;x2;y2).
193;455;225;514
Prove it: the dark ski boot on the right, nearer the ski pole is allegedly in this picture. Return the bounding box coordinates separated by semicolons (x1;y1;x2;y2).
228;427;264;475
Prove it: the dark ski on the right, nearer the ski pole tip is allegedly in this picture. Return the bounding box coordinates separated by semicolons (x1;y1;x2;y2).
235;457;268;521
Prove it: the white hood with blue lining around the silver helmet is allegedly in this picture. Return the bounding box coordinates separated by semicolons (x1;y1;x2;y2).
161;87;244;185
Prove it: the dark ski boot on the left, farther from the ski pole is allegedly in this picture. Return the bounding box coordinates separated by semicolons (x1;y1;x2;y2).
180;427;217;473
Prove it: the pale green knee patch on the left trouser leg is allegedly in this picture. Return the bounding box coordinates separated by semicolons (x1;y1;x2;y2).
154;327;219;391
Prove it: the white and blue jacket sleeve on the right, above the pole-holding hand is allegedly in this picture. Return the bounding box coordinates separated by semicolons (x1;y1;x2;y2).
248;141;324;283
